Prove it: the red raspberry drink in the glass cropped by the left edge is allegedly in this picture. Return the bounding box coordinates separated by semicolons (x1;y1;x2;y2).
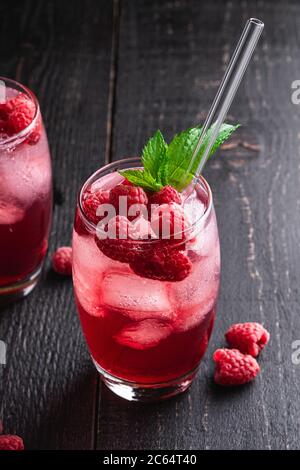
0;79;52;297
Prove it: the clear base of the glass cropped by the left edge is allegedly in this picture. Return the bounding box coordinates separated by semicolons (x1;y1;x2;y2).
0;262;43;305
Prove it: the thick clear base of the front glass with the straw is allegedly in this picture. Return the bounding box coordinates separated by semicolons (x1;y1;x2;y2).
92;358;198;402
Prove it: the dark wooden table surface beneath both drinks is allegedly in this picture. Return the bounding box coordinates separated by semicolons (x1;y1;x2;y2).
0;0;300;449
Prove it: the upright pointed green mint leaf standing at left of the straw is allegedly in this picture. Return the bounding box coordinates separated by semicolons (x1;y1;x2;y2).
142;130;168;182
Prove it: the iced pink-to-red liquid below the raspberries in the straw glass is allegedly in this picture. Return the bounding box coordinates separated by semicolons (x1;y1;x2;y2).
73;171;220;384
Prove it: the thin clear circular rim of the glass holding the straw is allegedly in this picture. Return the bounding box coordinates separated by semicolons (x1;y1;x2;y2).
77;157;213;243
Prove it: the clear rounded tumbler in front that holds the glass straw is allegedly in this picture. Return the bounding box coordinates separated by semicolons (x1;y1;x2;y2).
73;158;220;401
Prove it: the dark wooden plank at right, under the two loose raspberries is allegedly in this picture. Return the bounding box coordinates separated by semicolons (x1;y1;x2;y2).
97;0;300;449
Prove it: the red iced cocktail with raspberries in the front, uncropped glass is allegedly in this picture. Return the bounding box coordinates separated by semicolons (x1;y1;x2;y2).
73;159;220;400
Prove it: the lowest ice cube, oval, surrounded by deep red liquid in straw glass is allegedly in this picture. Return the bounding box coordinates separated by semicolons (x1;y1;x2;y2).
114;319;172;350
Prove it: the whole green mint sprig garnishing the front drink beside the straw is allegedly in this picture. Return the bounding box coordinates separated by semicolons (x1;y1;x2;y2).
120;124;240;191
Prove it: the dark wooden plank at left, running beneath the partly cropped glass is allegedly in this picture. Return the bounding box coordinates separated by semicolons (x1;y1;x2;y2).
0;0;112;449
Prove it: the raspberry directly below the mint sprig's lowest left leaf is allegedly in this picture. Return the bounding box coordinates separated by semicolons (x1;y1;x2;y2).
110;184;148;220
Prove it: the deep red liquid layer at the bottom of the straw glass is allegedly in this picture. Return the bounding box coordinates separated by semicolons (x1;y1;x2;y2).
78;303;214;383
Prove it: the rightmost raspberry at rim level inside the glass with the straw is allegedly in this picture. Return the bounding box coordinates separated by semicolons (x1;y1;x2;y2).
151;202;189;241
